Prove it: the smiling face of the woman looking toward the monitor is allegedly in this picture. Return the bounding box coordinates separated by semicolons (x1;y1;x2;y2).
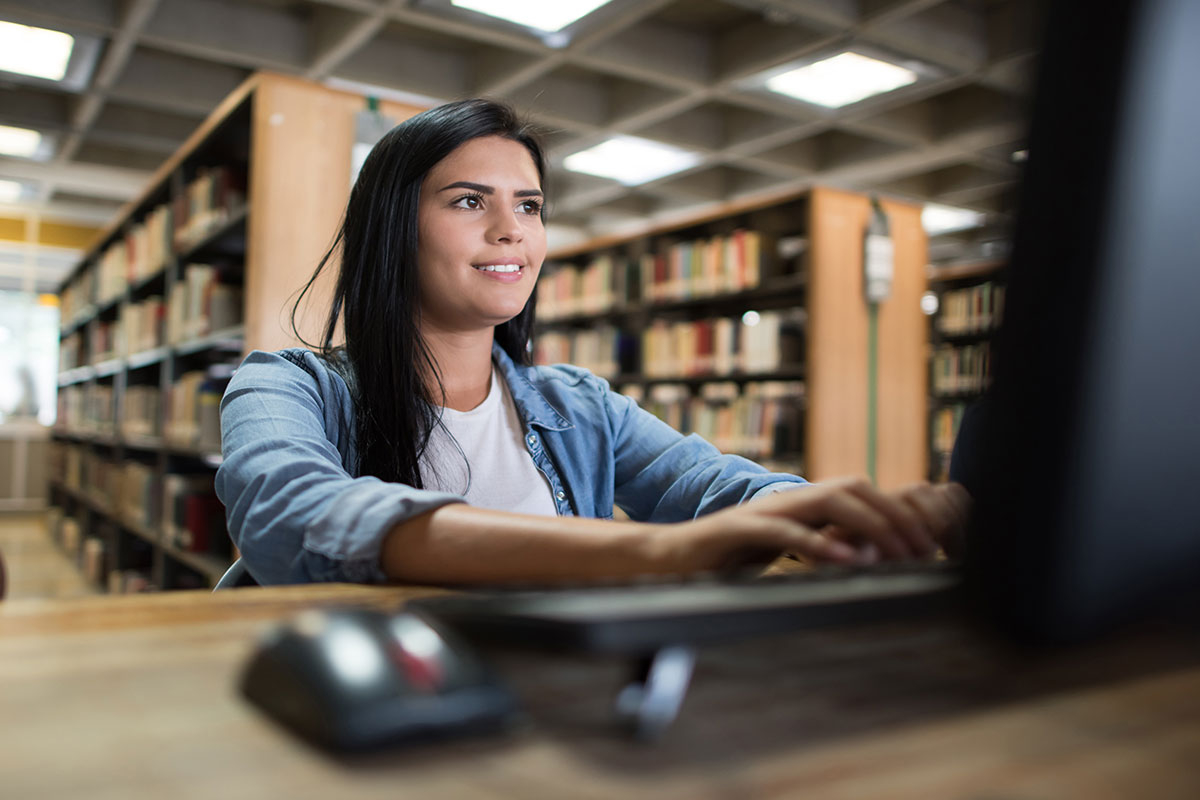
418;136;546;332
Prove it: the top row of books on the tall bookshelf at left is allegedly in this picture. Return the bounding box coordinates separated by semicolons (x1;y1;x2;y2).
61;166;246;311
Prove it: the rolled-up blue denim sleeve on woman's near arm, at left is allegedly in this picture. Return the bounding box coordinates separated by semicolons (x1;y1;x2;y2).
216;351;462;584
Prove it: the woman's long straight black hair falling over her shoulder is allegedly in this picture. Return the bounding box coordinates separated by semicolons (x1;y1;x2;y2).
292;100;546;488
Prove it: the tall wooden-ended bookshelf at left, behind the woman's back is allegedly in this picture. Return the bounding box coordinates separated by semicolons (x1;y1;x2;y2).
50;73;421;590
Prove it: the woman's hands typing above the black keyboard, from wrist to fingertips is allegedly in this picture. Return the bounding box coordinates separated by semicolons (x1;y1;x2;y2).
649;479;970;573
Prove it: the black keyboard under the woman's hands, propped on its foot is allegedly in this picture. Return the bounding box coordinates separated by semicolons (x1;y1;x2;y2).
408;561;960;654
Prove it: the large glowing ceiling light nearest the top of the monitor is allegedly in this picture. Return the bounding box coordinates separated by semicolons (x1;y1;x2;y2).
767;52;917;108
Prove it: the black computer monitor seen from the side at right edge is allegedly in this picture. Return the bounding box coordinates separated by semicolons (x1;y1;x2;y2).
956;0;1200;639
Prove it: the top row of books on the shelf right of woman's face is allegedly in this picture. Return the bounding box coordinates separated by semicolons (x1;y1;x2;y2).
538;229;764;321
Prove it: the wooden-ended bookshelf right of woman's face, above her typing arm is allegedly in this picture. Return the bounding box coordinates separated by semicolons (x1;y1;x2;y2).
535;188;929;487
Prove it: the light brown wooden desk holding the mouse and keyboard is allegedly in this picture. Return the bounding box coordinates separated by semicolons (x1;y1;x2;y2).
0;585;1200;800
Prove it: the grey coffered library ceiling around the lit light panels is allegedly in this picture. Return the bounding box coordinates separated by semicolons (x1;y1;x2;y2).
0;0;1037;266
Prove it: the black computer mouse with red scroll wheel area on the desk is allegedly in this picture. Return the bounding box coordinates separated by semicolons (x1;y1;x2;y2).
241;608;517;751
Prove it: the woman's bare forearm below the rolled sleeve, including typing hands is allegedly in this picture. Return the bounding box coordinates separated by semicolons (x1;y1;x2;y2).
380;480;967;585
